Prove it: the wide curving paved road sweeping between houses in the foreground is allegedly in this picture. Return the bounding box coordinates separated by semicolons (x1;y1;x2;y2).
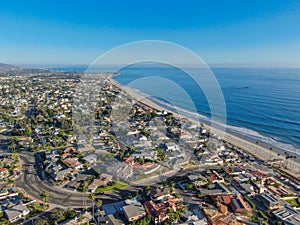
15;152;204;208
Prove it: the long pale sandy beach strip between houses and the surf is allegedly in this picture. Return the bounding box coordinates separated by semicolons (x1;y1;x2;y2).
108;76;300;178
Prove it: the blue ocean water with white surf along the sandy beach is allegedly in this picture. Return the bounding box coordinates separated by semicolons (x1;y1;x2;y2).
51;65;300;154
